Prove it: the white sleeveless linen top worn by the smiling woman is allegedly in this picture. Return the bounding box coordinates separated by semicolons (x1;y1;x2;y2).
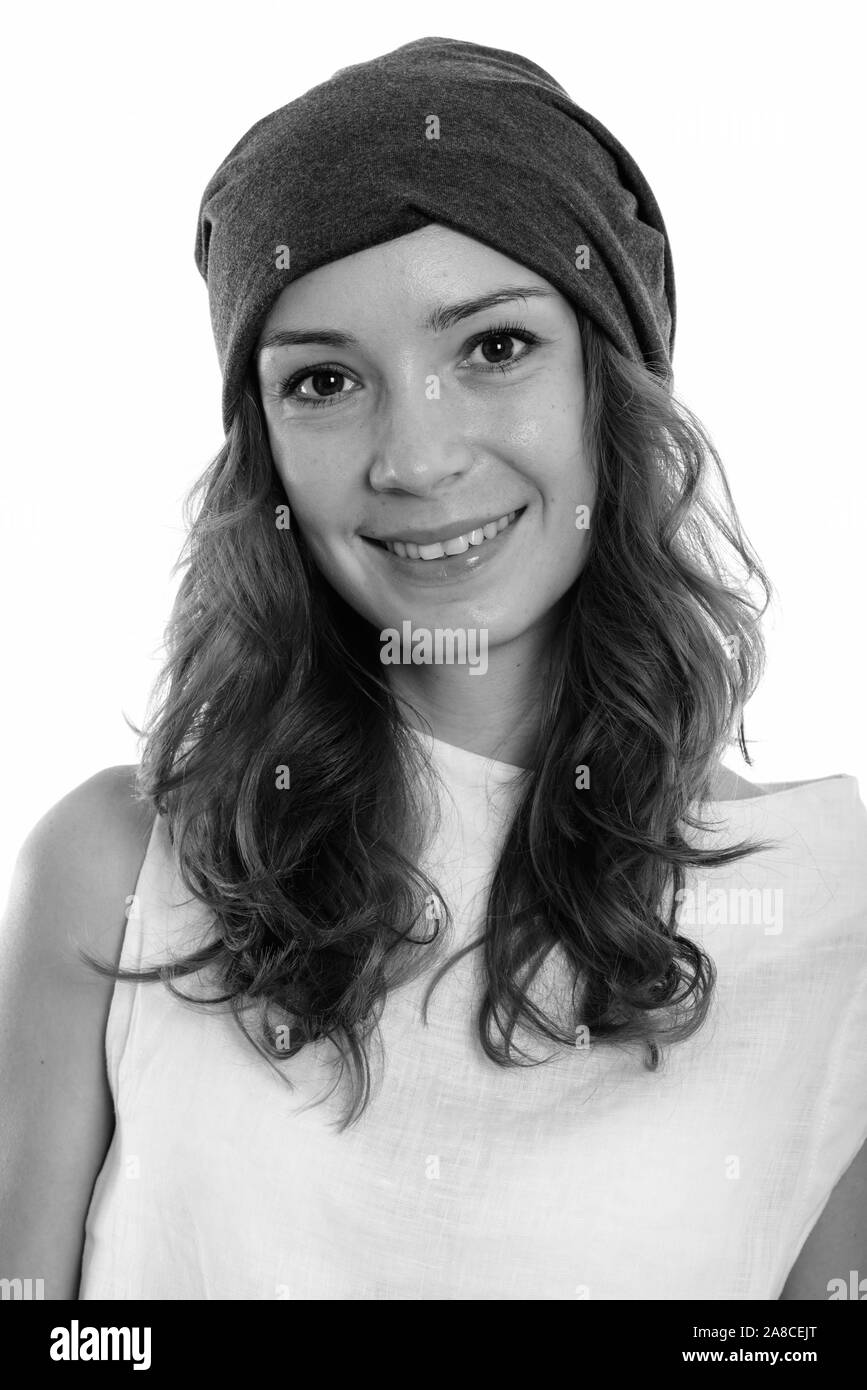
79;741;867;1300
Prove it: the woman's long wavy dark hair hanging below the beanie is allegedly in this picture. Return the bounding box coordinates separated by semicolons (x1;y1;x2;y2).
89;314;773;1130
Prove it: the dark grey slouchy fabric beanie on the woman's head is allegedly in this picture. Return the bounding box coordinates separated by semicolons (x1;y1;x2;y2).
196;38;675;431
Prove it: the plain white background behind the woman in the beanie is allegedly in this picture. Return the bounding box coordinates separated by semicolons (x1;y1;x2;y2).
0;0;867;892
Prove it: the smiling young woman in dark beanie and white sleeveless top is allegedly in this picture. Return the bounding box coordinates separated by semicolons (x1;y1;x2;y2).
0;39;867;1300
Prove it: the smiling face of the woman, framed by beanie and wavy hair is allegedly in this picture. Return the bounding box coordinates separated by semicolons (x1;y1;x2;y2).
257;225;595;649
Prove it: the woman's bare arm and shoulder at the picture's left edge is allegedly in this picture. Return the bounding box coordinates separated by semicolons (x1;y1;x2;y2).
0;767;154;1298
